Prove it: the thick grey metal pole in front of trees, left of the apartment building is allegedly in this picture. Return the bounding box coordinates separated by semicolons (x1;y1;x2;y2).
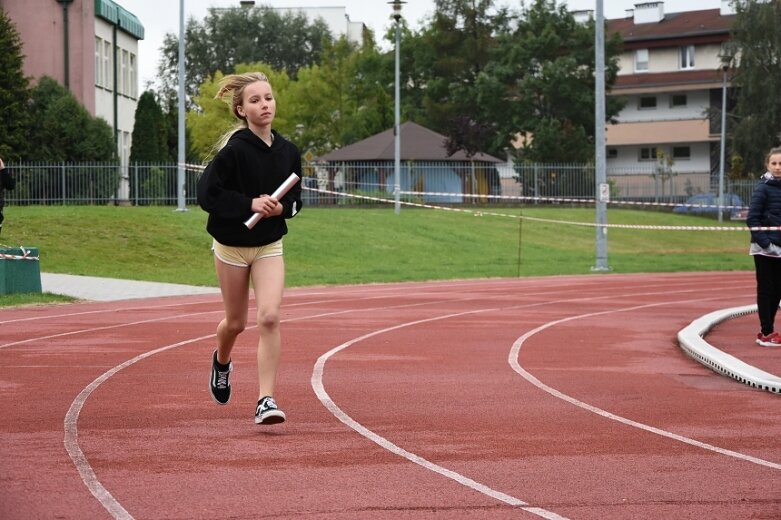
592;0;610;271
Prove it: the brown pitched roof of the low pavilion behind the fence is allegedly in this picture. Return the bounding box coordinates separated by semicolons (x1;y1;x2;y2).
318;122;502;163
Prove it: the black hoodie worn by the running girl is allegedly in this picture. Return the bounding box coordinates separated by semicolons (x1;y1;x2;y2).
198;128;301;247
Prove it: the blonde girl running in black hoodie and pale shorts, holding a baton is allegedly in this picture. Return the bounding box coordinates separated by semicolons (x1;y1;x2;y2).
198;72;301;424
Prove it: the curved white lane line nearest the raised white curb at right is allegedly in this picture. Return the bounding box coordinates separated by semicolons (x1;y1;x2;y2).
508;300;781;469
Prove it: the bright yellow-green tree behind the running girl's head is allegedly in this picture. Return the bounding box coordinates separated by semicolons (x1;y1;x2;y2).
187;33;393;160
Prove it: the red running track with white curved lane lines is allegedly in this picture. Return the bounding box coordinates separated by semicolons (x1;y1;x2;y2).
0;272;781;520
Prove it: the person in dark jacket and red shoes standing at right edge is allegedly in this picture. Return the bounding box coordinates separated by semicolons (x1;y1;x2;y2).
746;147;781;347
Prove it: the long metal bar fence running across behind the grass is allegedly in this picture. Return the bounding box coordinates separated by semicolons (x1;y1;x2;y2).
0;161;755;210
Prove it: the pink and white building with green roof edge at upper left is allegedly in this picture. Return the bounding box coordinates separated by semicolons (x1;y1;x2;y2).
0;0;144;169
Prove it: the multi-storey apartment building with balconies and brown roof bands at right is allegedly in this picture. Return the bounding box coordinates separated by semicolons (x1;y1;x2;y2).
606;0;735;192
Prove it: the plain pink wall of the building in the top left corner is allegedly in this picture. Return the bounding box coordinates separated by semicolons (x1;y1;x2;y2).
0;0;95;116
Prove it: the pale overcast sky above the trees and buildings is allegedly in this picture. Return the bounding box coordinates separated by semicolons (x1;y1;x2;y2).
116;0;721;89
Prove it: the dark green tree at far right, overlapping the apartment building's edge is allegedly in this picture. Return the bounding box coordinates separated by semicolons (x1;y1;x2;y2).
731;0;781;177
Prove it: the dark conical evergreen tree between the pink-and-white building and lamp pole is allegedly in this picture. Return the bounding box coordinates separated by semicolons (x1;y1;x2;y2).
130;90;170;162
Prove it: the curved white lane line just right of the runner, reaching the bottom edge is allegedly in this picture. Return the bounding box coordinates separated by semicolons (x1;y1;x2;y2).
311;309;566;520
